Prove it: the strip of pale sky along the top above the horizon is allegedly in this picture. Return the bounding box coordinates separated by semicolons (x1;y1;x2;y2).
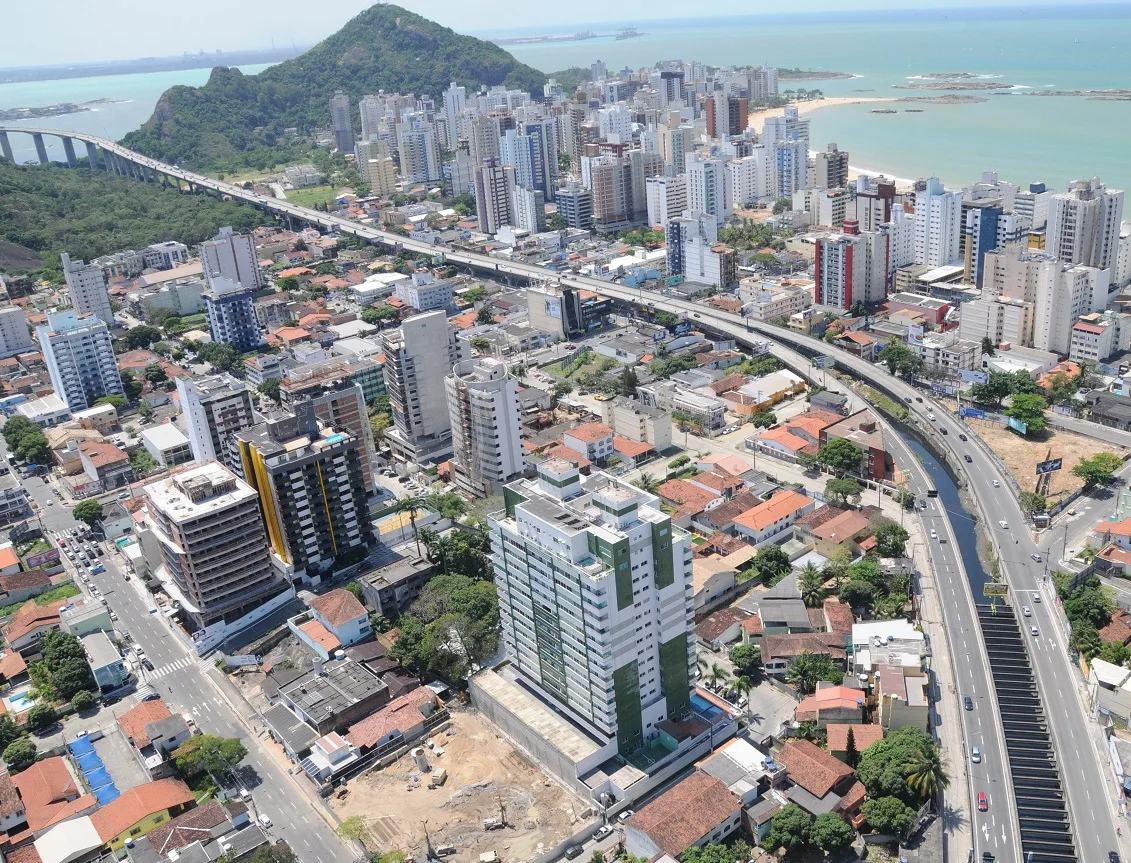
2;0;1131;69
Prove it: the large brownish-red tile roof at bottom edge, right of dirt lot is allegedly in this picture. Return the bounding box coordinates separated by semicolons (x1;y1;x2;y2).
625;770;741;858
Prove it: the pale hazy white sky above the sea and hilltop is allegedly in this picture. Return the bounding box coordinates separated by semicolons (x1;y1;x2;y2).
0;0;1112;67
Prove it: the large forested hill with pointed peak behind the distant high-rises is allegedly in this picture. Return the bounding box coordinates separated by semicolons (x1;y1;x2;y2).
122;6;545;169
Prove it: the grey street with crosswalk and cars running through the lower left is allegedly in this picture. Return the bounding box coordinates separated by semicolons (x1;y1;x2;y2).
0;443;359;863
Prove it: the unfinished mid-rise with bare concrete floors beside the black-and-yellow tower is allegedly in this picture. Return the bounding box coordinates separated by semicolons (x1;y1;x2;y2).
143;461;288;628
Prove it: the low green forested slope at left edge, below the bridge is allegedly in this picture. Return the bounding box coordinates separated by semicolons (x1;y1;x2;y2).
0;158;266;269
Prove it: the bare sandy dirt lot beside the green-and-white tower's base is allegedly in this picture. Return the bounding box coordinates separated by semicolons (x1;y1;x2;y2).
333;710;589;863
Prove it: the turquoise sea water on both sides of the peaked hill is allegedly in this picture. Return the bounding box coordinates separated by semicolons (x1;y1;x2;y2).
0;3;1131;189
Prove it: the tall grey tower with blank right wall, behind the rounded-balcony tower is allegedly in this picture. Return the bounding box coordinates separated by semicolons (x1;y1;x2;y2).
382;311;465;464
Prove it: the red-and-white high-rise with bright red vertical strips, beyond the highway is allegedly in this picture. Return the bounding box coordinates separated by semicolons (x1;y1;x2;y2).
813;222;888;310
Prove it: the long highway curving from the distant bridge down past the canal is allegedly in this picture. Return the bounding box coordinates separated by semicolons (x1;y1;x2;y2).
0;127;1131;861
